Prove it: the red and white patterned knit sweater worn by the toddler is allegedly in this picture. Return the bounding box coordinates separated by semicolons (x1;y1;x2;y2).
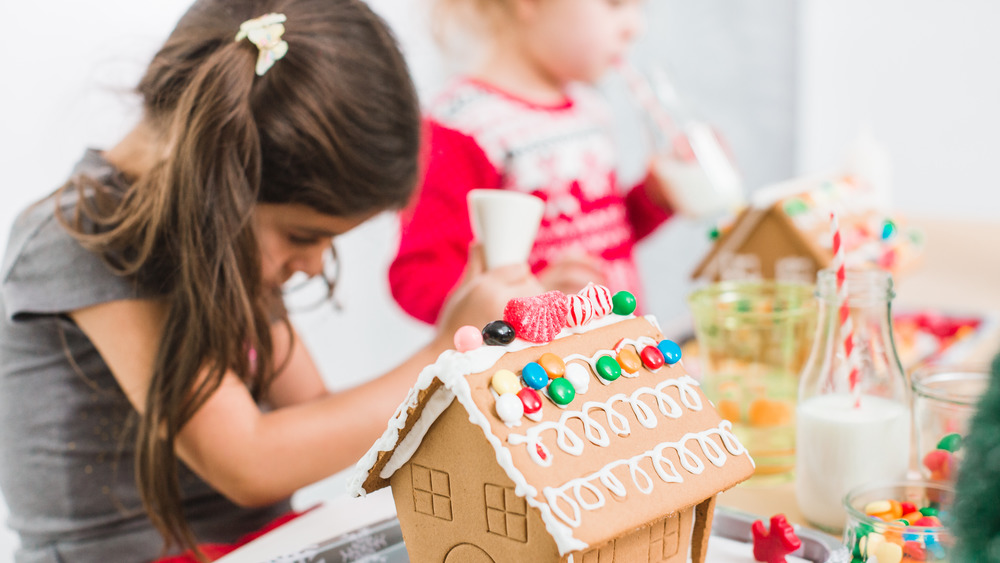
389;79;670;323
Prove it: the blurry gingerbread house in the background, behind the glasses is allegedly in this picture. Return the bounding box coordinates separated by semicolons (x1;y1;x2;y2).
692;176;923;283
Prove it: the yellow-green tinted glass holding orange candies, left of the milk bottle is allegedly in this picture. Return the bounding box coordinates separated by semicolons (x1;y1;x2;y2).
688;280;816;482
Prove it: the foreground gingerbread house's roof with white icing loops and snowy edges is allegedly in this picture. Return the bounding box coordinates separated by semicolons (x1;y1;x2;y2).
351;314;753;555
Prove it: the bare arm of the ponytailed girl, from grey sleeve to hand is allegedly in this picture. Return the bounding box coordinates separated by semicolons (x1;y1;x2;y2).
71;265;537;506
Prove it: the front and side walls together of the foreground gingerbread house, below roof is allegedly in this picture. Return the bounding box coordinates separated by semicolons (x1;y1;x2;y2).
390;401;714;563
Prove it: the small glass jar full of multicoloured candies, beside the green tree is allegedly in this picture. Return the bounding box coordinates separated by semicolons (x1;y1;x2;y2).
844;480;955;563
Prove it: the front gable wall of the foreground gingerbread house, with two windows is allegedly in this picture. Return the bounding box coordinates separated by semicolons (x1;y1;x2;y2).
390;401;560;563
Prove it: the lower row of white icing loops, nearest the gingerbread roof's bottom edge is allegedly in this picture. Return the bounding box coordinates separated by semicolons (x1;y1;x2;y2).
542;420;753;528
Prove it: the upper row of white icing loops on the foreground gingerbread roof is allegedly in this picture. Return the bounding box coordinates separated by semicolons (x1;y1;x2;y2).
507;375;702;467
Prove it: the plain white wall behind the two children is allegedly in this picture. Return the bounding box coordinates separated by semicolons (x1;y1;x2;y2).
0;0;1000;563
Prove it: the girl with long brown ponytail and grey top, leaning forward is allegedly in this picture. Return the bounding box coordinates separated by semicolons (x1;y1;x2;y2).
0;0;539;562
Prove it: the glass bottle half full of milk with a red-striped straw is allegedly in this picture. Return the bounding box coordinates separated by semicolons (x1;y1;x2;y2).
795;270;910;532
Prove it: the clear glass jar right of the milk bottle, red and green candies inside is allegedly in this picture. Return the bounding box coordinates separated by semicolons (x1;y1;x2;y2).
910;364;990;483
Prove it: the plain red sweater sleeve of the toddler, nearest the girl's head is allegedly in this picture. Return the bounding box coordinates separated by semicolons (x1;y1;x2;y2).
389;122;500;324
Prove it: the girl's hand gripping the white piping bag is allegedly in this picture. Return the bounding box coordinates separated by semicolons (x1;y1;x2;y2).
438;245;545;340
